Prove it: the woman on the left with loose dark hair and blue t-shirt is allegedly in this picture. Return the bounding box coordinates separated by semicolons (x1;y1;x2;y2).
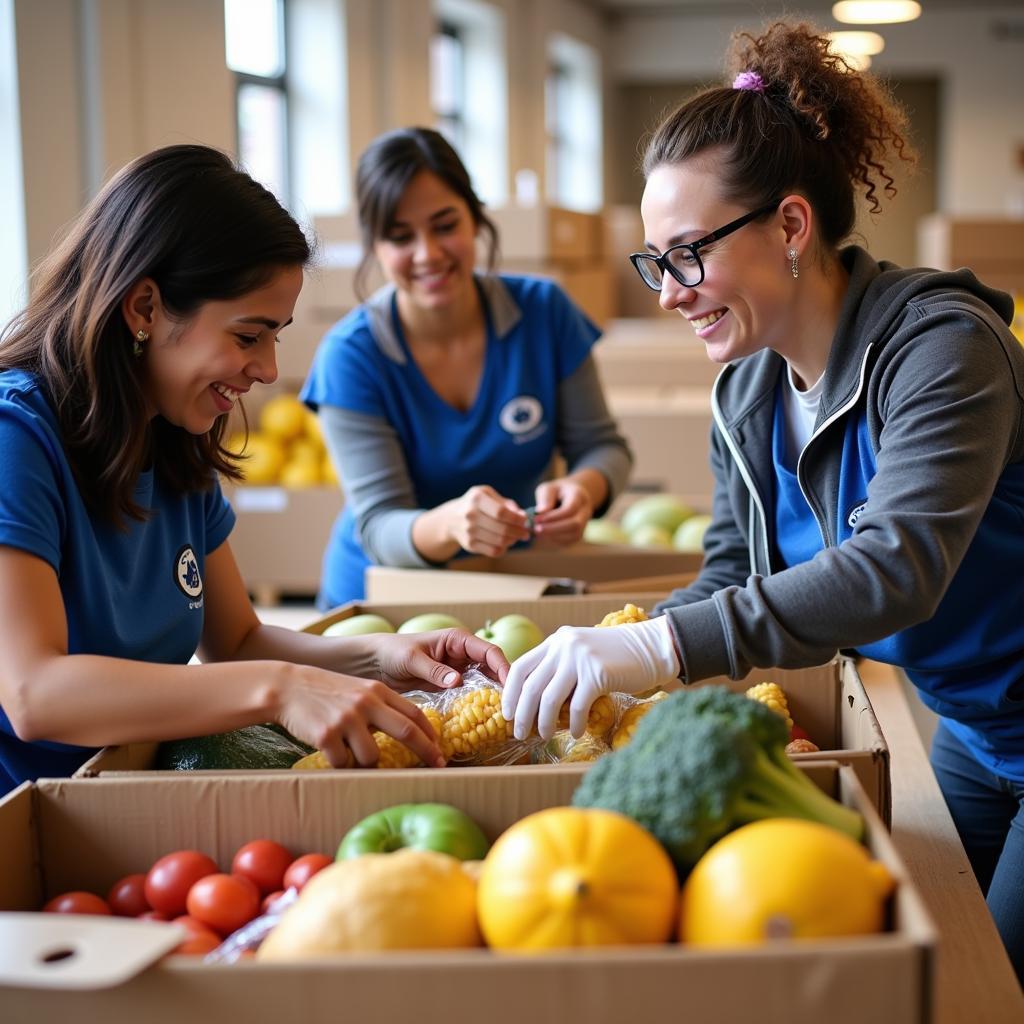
0;145;507;793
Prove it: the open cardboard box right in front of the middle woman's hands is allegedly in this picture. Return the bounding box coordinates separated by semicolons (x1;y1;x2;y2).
366;544;703;603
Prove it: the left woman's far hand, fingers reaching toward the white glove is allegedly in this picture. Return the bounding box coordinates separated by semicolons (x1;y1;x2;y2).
366;629;509;689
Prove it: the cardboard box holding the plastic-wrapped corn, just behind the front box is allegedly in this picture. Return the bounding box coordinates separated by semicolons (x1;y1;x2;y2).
77;592;891;823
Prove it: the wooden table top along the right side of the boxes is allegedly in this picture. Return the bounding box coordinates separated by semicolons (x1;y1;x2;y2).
859;662;1024;1024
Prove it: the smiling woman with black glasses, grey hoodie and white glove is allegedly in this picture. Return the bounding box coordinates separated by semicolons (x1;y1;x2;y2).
504;23;1024;975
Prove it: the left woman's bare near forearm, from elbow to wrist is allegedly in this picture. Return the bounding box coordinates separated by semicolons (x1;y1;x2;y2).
11;654;289;746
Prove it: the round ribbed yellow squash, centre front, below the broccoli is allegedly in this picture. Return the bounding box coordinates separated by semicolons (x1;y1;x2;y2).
477;807;678;950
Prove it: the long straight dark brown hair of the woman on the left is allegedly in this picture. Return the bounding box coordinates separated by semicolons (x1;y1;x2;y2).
0;145;310;524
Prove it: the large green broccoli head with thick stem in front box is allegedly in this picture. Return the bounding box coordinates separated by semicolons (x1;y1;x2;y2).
572;686;863;876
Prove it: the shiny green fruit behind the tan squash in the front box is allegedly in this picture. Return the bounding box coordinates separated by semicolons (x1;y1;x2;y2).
335;804;490;860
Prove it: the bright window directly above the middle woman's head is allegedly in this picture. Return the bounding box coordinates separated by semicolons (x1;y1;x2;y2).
430;0;508;206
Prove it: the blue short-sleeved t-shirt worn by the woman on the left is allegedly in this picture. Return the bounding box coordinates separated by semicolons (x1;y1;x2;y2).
0;370;234;794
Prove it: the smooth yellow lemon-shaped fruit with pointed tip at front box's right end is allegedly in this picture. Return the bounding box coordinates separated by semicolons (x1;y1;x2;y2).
679;818;895;946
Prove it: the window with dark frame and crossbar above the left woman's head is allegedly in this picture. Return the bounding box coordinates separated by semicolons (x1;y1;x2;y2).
224;0;290;202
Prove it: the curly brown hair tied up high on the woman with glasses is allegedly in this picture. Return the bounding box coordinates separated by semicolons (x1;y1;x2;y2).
643;22;915;247
